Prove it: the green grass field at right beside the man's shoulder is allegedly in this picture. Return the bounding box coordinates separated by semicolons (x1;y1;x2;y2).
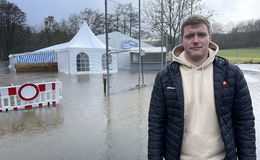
218;48;260;63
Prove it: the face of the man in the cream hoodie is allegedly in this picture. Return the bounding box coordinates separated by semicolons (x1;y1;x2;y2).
182;24;211;62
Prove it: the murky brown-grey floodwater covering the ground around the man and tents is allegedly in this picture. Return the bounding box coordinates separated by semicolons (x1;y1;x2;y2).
0;62;260;160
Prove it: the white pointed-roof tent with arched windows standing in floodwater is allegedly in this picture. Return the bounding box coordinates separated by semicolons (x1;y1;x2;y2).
10;22;117;74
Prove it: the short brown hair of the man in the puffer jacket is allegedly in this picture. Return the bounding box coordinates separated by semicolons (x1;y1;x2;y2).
181;15;211;37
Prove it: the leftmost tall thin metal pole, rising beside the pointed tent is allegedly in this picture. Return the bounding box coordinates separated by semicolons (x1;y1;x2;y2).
105;0;110;97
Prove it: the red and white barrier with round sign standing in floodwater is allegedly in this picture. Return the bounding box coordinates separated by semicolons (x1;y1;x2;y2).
0;81;62;112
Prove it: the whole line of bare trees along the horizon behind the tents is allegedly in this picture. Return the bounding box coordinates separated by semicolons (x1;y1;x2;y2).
0;0;260;60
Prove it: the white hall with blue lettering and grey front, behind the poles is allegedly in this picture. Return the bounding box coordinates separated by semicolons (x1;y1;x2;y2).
97;32;166;71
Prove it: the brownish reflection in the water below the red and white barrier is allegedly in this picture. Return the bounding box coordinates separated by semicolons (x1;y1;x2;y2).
0;105;64;136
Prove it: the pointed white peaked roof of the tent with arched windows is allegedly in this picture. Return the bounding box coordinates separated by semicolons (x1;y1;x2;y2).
37;21;106;52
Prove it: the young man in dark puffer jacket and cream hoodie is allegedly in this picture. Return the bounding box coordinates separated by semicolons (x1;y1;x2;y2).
148;16;256;160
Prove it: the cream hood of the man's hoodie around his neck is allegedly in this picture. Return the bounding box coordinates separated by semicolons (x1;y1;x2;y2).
172;42;219;69
